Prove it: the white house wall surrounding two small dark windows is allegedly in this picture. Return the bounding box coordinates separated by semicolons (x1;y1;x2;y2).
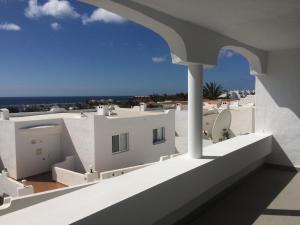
95;110;175;172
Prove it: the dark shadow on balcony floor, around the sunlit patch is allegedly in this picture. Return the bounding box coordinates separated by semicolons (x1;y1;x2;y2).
175;166;299;225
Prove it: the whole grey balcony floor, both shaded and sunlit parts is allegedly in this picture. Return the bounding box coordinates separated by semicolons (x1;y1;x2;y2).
176;167;300;225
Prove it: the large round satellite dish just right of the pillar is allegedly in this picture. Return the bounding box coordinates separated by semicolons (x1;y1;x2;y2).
211;109;231;143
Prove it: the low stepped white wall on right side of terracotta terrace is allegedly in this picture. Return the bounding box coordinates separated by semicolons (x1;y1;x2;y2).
52;156;99;186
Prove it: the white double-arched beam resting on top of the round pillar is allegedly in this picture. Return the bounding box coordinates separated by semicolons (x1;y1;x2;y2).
80;0;267;70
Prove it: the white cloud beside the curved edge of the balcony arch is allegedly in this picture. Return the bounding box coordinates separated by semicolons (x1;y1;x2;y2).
82;9;126;25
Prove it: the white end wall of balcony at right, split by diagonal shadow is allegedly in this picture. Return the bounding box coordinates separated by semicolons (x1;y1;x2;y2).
256;48;300;167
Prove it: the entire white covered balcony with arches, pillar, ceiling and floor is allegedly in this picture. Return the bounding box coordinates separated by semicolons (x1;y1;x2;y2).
0;0;300;225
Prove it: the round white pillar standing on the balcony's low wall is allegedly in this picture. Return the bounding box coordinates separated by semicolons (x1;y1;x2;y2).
188;64;203;159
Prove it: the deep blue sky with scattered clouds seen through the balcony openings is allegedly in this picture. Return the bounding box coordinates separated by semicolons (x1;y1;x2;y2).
0;0;254;97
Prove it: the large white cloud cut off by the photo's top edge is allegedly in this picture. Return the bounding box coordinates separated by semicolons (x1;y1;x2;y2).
25;0;80;18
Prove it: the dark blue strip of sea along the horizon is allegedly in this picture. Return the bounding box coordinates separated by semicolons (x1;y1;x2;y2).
0;96;129;107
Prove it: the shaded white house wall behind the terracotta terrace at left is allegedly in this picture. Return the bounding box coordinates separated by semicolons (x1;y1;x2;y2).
14;119;63;179
